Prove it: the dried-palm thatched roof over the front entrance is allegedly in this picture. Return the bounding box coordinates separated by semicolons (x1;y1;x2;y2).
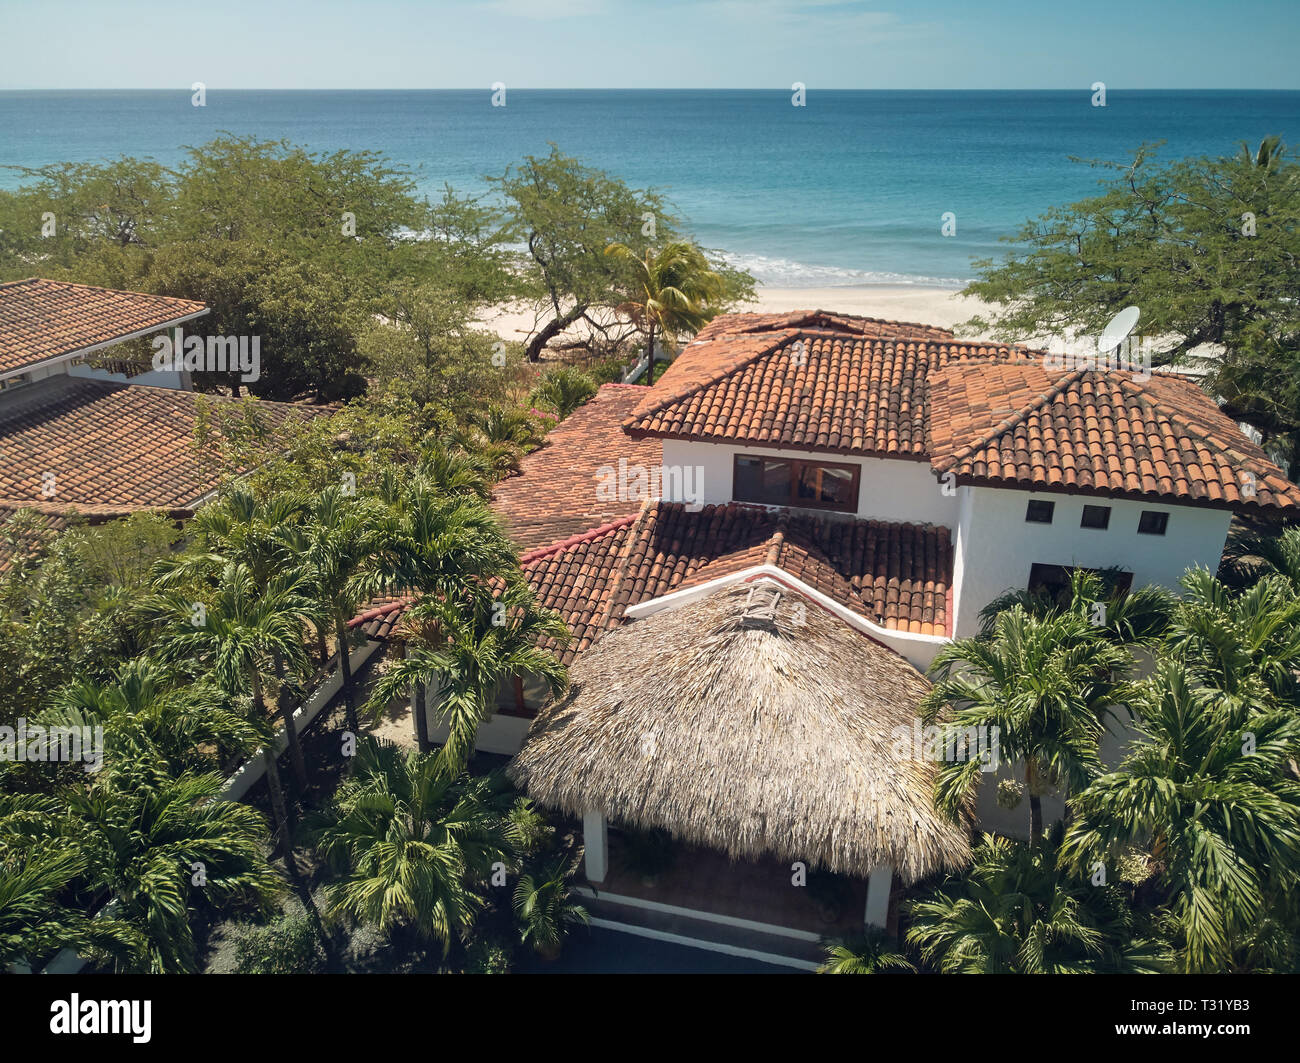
510;582;970;882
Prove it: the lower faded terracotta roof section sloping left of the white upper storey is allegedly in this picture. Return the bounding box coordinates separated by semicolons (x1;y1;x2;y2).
493;383;663;550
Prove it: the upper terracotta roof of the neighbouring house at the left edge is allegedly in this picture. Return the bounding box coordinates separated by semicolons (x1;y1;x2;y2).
0;277;207;373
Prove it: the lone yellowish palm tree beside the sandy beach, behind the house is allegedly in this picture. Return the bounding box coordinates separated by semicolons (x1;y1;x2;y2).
605;240;725;385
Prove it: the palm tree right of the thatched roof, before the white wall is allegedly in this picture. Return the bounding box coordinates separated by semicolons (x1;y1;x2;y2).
920;606;1131;845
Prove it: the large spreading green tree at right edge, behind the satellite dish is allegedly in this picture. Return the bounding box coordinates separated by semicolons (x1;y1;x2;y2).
965;138;1300;478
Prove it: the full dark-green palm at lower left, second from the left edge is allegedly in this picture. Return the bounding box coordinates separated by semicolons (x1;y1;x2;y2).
64;765;283;973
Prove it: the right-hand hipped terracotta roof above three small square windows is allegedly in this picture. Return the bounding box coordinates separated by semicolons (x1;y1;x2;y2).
930;365;1300;511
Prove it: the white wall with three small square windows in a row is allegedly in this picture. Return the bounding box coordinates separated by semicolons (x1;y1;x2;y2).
953;487;1232;638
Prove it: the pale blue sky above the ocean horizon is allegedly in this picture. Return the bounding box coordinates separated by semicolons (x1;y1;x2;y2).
0;0;1300;90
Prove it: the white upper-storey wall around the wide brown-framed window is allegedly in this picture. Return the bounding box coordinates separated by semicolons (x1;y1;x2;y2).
663;439;959;528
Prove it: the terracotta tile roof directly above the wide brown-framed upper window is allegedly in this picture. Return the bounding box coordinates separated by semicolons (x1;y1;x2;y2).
624;326;1040;459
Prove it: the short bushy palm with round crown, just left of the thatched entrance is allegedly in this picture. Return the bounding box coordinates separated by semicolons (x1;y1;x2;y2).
316;736;512;954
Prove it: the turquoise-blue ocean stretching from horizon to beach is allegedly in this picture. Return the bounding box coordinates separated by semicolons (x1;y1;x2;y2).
0;88;1300;287
